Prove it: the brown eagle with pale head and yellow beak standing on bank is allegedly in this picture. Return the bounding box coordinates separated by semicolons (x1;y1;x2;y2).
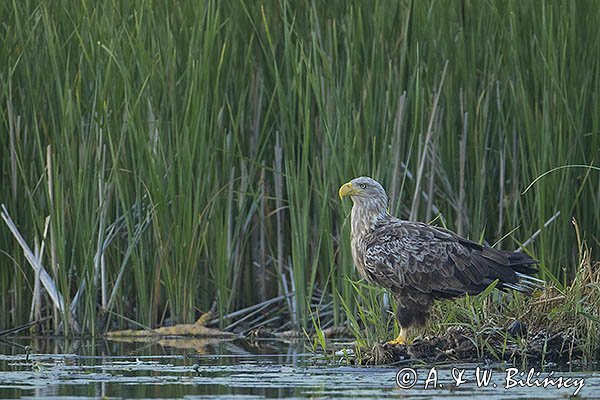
339;177;543;344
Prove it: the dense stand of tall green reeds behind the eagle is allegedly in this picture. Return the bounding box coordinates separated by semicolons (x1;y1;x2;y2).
0;0;600;332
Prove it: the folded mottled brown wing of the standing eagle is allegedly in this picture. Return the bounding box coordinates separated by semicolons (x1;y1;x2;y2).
363;217;537;298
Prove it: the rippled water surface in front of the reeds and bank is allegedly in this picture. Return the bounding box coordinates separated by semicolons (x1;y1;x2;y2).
0;339;600;400
